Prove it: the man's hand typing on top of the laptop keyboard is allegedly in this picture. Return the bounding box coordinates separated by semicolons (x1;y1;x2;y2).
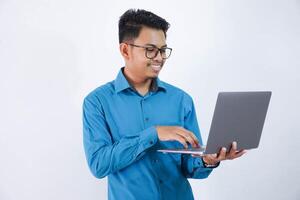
156;126;199;148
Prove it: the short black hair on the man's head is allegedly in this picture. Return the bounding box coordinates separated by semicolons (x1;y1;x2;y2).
119;9;170;43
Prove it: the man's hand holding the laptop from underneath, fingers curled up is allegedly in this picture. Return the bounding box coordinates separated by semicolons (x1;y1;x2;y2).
193;142;246;165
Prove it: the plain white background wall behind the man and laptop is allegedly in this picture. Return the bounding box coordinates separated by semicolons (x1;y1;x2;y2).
0;0;300;200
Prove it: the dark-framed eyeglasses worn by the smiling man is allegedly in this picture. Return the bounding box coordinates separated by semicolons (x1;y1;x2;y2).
128;44;172;59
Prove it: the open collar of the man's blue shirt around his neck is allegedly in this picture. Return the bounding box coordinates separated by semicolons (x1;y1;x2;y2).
114;67;166;93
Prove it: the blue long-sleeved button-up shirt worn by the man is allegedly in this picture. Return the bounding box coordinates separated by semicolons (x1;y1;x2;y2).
83;69;216;200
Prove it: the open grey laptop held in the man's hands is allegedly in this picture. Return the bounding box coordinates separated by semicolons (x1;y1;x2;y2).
157;91;272;156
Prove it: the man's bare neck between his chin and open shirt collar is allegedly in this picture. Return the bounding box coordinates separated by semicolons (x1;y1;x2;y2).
124;67;152;95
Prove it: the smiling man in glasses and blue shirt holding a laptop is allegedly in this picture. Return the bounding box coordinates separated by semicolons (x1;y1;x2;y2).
83;10;245;200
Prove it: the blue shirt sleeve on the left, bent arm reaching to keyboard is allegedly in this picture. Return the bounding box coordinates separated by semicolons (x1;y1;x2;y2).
83;97;158;178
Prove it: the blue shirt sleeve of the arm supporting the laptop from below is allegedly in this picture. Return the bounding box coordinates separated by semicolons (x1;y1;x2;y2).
181;94;217;179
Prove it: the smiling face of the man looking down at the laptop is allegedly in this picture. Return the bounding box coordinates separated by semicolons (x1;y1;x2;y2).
126;27;167;79
